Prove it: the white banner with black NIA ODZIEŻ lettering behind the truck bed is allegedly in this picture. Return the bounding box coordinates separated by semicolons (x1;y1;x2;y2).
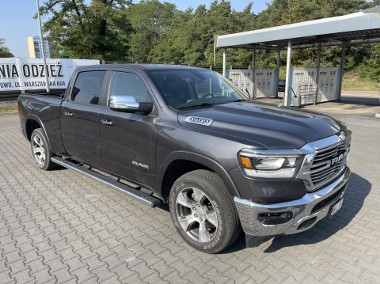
0;58;99;92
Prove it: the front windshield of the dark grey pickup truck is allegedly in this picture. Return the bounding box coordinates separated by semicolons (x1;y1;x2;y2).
149;69;247;109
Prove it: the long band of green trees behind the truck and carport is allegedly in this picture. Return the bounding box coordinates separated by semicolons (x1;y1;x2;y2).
38;0;380;79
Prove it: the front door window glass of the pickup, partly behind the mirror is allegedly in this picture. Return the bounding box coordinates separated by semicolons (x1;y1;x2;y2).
108;72;152;105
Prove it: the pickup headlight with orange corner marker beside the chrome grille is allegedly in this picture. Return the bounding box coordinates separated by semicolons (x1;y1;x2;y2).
238;150;303;178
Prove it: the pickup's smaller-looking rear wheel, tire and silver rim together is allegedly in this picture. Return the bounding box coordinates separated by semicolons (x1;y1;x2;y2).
30;128;57;171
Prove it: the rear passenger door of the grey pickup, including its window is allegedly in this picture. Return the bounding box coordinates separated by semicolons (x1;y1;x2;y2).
60;70;106;167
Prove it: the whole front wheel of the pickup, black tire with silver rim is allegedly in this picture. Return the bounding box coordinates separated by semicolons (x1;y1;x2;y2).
169;170;241;253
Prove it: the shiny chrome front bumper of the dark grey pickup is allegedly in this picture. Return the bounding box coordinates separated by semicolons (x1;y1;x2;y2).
234;168;351;236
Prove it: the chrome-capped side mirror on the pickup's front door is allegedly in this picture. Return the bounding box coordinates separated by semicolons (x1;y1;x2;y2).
110;96;153;113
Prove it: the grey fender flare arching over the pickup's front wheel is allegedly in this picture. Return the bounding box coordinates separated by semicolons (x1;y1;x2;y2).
156;151;240;197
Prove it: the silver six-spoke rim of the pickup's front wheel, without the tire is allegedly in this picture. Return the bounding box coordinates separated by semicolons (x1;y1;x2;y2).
176;188;218;243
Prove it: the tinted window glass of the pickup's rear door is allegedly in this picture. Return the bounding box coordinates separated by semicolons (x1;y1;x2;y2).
71;71;106;105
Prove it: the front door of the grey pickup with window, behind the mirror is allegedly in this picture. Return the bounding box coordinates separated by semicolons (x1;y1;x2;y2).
99;71;157;187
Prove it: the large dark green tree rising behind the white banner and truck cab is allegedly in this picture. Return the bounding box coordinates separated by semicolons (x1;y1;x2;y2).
41;0;131;60
